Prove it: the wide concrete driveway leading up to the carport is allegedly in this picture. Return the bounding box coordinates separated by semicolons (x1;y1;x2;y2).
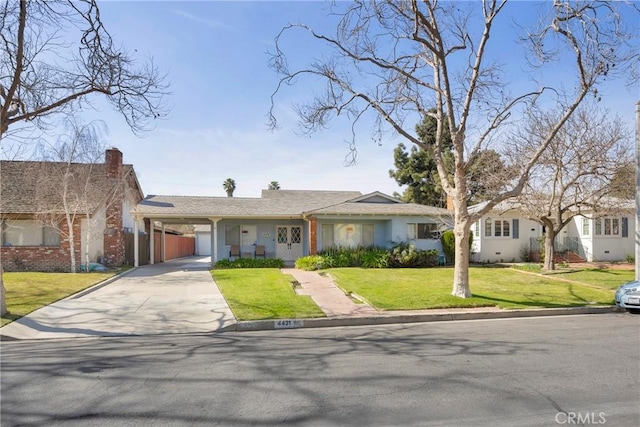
0;257;236;339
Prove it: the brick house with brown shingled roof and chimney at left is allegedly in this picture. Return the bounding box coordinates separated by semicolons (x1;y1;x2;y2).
0;148;144;271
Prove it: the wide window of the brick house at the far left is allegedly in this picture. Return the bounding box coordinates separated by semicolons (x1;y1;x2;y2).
2;219;60;246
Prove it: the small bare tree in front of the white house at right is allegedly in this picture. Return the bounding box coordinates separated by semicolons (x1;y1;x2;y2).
512;104;633;270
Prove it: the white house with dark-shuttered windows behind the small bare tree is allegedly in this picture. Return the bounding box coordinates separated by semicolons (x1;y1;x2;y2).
469;200;635;263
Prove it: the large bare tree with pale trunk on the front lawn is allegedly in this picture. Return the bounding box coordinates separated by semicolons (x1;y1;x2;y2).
270;0;638;297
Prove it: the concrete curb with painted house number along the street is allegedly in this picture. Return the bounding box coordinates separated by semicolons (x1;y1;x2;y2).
230;305;624;332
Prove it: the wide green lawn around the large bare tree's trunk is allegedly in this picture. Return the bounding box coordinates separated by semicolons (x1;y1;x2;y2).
327;268;613;310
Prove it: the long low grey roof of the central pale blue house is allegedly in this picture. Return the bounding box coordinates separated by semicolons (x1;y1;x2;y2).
133;190;450;220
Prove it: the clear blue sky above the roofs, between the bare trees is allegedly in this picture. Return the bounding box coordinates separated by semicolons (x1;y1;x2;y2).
26;1;639;197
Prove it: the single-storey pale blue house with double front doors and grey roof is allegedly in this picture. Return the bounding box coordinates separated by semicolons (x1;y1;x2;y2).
132;190;451;263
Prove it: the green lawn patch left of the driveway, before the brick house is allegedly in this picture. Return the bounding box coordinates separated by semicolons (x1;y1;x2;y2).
0;272;116;326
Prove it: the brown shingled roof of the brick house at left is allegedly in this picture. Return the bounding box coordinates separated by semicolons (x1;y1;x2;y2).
0;160;140;214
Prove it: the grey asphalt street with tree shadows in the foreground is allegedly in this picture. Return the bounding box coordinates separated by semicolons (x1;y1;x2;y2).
0;313;640;426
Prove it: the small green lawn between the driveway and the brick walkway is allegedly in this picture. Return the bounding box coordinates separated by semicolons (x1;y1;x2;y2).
211;268;324;320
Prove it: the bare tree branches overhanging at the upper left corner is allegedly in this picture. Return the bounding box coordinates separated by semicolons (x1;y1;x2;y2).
0;0;168;314
